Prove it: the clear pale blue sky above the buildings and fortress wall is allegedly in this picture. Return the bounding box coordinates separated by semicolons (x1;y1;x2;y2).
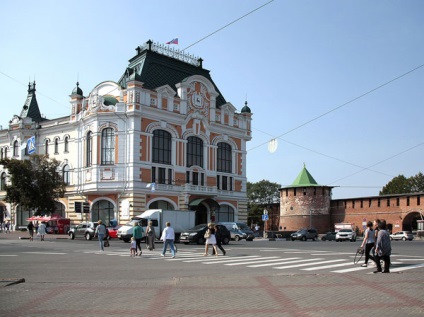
0;0;424;199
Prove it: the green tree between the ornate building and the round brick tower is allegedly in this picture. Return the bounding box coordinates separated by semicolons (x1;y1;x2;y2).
247;180;281;223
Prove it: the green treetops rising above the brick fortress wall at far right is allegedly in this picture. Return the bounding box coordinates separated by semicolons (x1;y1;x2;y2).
380;172;424;195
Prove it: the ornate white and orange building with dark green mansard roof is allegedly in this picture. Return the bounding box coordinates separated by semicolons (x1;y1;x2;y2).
0;41;252;227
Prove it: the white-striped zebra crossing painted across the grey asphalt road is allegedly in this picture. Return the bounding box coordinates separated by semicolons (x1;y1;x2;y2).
145;250;424;273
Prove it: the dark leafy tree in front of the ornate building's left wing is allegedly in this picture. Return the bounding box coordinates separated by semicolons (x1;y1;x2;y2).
0;155;66;215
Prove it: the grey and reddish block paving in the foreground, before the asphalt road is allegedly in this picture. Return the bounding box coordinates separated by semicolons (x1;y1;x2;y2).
0;233;424;317
